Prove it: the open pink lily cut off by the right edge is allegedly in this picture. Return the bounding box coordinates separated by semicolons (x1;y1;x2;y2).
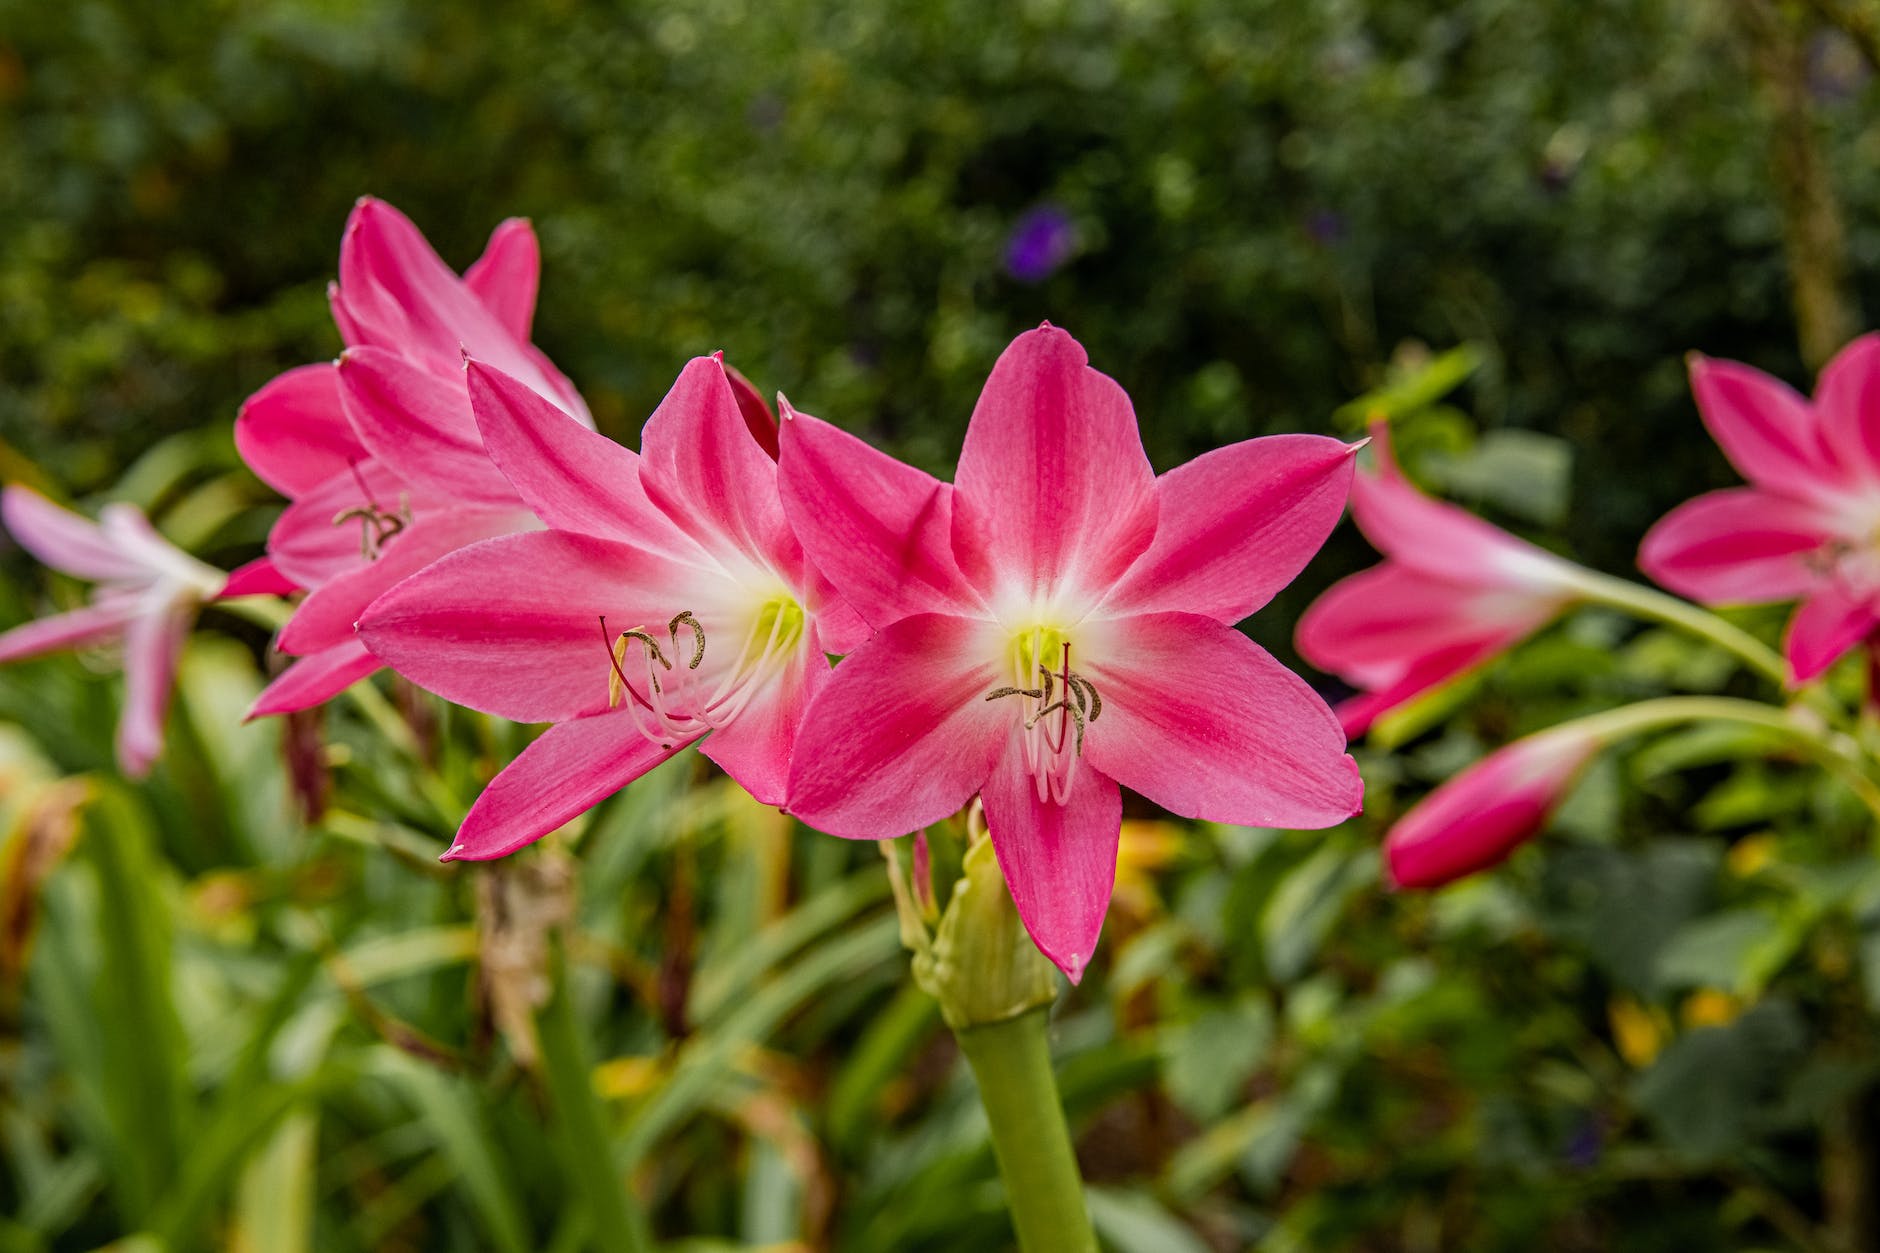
1639;335;1880;685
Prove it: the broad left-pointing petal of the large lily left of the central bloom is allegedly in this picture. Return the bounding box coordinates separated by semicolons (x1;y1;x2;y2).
359;531;720;722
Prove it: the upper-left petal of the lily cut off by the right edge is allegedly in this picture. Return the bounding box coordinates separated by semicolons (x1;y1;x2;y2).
1690;354;1844;497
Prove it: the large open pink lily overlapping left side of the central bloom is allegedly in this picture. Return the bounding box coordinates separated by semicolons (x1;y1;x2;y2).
359;357;865;860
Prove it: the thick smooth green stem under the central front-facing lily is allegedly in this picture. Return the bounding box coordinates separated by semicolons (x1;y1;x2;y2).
955;1008;1096;1253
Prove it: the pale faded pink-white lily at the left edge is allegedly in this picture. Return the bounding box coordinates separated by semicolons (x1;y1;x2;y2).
0;485;232;767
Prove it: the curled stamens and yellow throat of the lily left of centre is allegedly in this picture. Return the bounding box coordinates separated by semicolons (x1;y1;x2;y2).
600;596;805;749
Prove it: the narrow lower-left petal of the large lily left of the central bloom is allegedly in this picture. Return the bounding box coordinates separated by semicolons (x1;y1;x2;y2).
440;713;684;862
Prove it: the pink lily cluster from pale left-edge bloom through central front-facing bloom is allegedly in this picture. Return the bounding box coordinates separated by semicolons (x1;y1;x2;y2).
0;199;1361;980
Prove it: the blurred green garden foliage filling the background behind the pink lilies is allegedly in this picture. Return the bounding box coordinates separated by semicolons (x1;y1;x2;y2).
0;0;1880;1253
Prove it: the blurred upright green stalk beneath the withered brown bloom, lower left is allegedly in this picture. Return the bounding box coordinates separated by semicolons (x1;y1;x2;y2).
536;939;652;1253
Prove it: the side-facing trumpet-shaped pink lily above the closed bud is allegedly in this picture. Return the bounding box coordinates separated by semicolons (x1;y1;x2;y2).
1293;423;1581;736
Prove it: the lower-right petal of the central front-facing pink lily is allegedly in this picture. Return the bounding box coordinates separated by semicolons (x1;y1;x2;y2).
1072;613;1363;828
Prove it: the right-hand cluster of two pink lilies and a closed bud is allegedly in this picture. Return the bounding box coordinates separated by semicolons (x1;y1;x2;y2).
1297;335;1880;888
